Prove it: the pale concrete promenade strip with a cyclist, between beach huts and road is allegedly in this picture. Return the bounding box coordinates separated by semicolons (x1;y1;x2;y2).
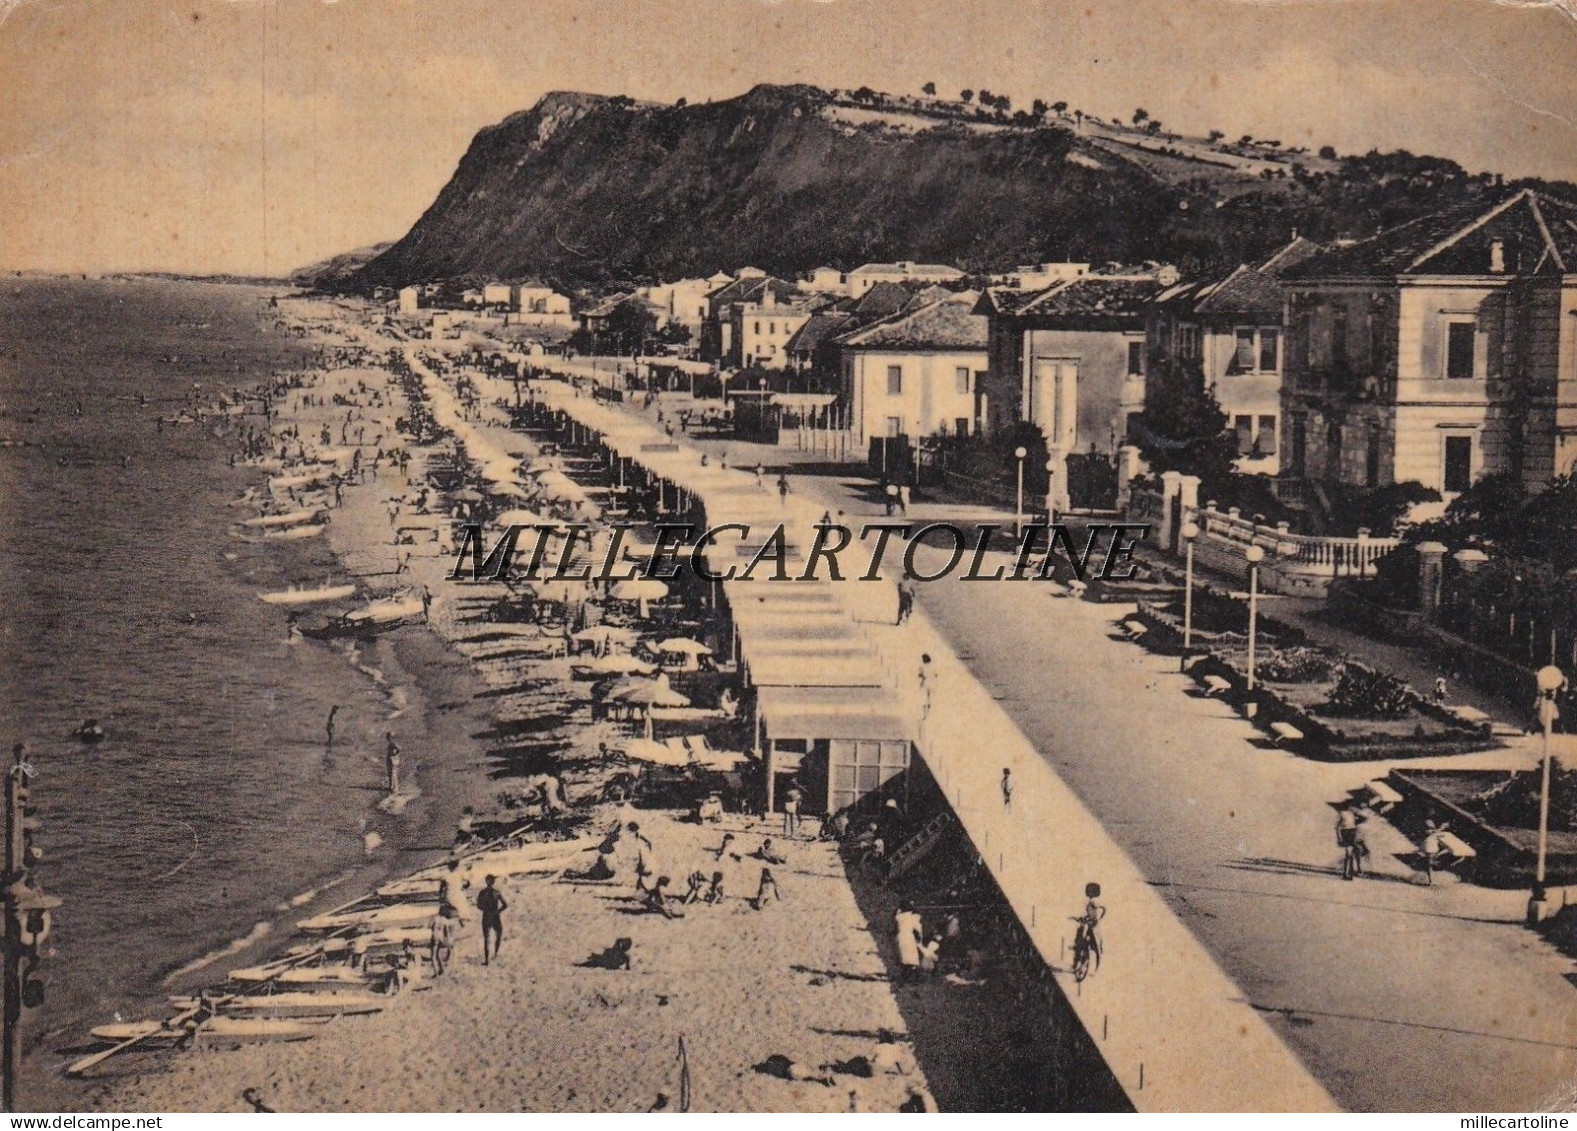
498;377;1336;1110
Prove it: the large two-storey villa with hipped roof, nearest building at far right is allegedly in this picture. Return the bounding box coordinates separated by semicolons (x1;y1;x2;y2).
1281;189;1577;498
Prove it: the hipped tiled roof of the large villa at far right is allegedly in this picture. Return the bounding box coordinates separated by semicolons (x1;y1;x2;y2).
1284;189;1577;279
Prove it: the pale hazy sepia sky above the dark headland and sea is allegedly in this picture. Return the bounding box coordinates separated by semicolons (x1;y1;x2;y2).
0;0;1577;274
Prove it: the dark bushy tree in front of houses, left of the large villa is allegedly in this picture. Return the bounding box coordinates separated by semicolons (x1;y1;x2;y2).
1134;360;1238;497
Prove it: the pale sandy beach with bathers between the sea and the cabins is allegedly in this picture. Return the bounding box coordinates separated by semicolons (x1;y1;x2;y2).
68;303;1033;1110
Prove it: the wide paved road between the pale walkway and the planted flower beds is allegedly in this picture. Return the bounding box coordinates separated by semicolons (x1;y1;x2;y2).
769;460;1577;1110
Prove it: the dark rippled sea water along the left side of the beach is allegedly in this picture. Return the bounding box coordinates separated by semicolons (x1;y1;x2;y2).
0;278;428;1041
